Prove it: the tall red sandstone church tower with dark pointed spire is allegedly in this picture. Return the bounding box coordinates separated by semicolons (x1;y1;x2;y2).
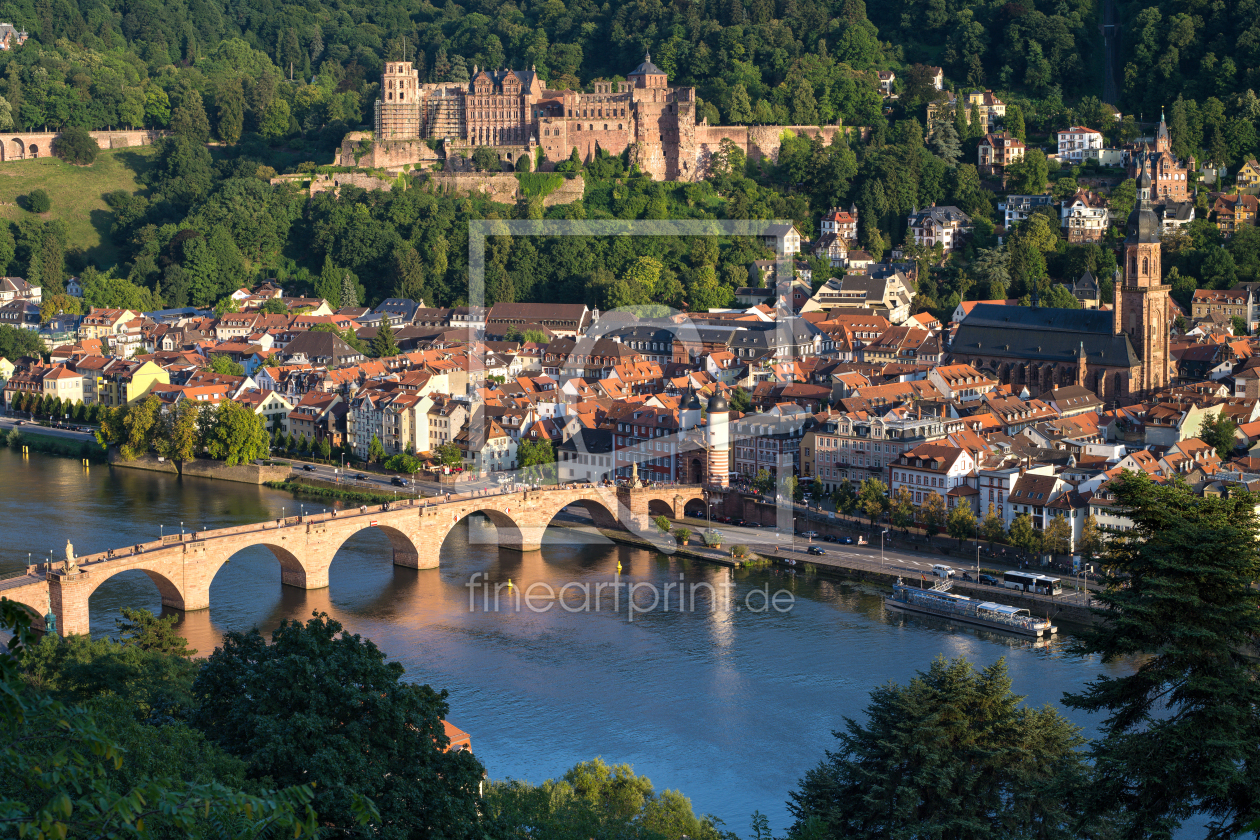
1114;153;1172;392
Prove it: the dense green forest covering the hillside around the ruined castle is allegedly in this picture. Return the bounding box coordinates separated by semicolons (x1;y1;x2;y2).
0;0;1260;322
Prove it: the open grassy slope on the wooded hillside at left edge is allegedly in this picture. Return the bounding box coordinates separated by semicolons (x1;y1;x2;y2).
0;146;155;268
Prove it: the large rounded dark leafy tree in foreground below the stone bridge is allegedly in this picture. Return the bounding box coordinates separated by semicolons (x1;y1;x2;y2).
192;615;484;839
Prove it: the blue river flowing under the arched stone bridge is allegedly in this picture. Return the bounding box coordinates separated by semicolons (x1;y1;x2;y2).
0;450;1120;835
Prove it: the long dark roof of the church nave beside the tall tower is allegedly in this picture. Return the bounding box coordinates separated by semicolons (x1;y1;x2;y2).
950;304;1138;368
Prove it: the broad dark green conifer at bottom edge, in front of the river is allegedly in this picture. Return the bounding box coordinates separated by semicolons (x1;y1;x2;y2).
788;657;1087;840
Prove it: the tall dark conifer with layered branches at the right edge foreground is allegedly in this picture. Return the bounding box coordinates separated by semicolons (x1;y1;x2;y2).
1065;472;1260;839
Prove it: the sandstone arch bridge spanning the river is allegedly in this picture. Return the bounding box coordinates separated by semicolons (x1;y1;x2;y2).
0;485;704;636
